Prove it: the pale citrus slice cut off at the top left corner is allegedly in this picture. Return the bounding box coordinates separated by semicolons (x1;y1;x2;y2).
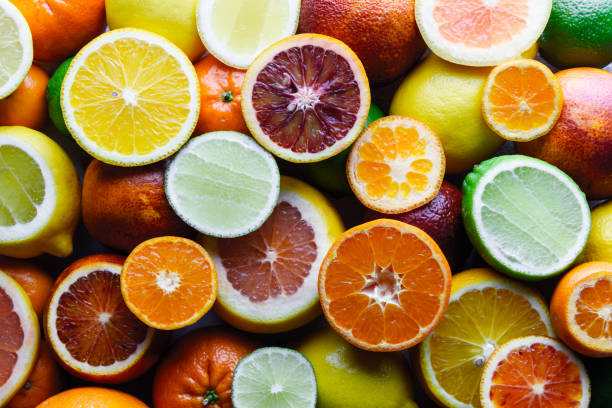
0;0;33;99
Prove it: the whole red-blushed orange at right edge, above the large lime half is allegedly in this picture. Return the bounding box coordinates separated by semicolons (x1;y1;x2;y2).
516;68;612;198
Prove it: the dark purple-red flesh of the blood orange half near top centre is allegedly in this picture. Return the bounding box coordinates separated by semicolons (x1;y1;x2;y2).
253;45;361;153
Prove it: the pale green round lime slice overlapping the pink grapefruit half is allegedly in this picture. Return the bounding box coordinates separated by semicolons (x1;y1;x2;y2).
166;131;280;238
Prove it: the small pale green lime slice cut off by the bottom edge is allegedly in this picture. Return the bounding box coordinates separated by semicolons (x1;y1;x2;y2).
232;347;317;408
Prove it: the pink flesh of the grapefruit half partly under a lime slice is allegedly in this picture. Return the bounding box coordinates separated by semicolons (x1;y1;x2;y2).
219;201;317;302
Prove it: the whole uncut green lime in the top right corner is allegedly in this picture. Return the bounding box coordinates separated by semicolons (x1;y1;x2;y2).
539;0;612;68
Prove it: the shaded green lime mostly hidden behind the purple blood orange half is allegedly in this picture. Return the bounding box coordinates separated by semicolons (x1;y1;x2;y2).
301;104;384;196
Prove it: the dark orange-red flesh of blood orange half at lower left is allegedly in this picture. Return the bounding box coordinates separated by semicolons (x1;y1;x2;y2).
56;270;148;367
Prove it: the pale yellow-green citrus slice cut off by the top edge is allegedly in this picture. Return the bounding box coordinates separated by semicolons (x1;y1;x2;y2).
196;0;300;69
